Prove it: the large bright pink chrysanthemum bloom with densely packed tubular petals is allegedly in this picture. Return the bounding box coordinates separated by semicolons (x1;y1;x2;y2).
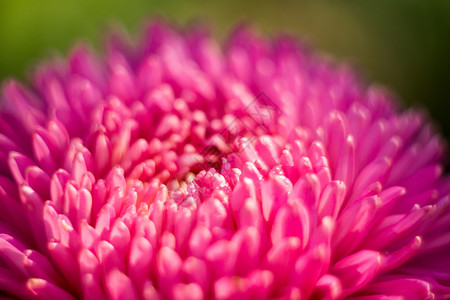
0;19;450;299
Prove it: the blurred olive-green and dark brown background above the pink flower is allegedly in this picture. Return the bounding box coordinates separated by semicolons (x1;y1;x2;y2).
0;0;450;137
